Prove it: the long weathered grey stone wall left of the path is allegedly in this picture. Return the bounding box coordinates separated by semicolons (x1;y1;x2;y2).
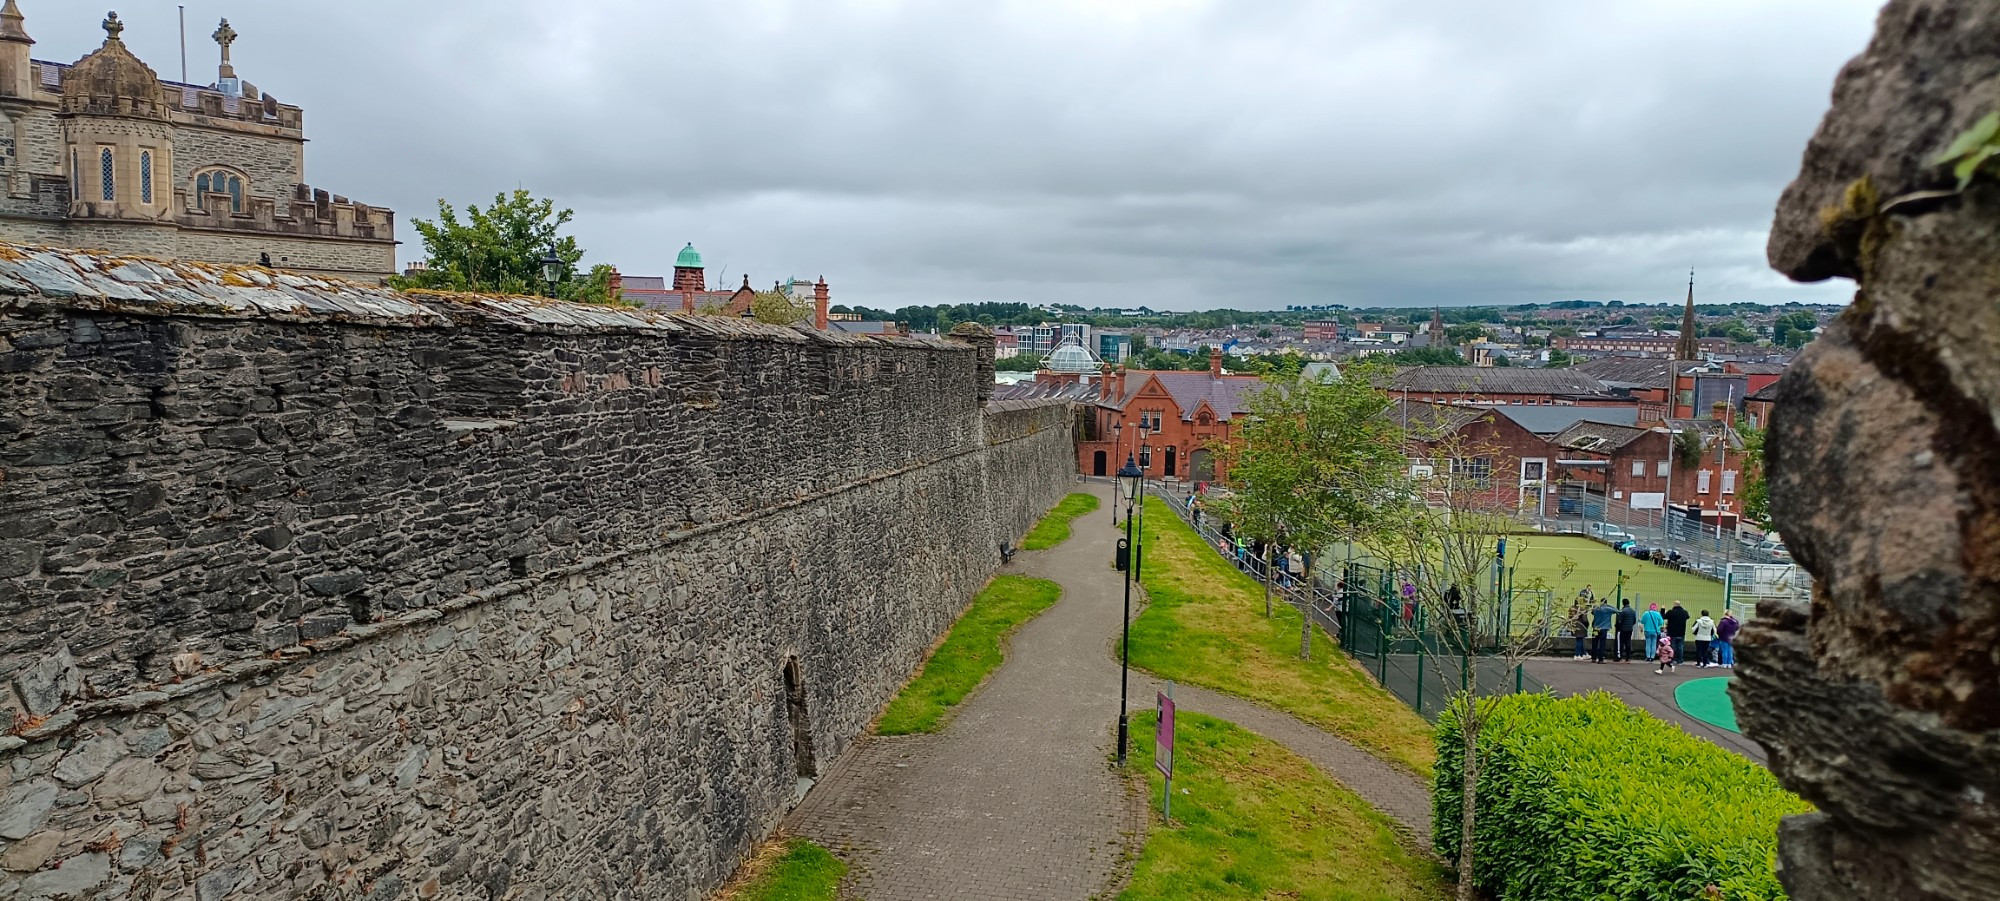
0;252;1072;901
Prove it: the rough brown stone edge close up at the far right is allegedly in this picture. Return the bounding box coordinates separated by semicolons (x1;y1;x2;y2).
1736;0;2000;901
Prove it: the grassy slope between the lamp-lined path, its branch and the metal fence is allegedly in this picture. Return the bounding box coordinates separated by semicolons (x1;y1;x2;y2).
1132;499;1436;777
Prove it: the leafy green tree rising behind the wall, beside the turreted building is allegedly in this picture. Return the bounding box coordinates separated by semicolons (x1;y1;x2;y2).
390;190;624;304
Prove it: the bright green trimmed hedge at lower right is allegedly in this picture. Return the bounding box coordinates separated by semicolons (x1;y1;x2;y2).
1432;693;1812;901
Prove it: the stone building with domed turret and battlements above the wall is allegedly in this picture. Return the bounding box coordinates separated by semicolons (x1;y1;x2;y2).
0;0;396;282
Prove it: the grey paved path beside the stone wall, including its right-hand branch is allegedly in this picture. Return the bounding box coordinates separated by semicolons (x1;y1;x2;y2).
786;485;1430;901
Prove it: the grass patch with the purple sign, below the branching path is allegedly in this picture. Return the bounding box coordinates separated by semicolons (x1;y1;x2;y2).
1118;713;1444;901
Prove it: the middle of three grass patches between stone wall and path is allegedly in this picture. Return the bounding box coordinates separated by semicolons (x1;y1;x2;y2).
876;575;1062;735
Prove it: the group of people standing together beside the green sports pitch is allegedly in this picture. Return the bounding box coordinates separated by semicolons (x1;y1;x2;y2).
1570;585;1742;673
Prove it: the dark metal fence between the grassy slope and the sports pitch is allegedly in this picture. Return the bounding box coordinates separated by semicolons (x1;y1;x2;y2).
1158;493;1550;719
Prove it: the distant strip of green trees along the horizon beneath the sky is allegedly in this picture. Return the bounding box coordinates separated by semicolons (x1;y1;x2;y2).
832;300;1810;332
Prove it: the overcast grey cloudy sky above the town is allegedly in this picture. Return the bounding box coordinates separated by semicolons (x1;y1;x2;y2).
20;0;1878;308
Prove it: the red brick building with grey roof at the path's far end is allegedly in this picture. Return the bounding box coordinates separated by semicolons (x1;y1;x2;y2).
1076;350;1262;481
